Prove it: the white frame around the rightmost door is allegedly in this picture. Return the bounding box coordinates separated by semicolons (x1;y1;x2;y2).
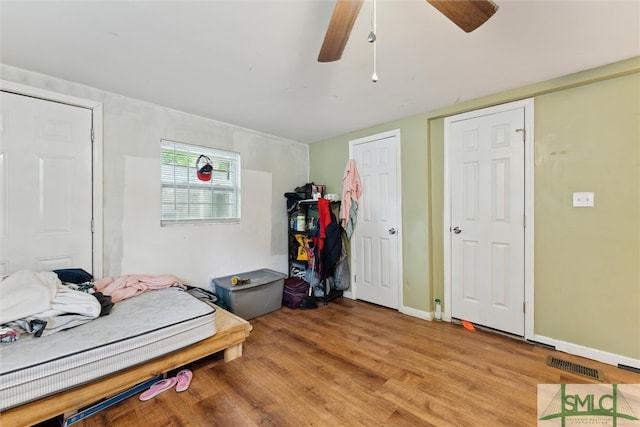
443;98;534;340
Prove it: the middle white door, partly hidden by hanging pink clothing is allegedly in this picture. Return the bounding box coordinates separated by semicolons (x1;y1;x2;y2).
350;131;401;309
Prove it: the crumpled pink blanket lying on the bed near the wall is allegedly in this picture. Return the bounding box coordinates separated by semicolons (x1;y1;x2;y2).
94;274;186;302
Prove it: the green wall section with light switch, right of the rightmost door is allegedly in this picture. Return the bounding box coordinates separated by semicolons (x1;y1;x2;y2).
534;74;640;358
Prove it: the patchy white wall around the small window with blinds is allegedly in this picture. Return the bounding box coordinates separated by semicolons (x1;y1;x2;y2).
0;64;309;287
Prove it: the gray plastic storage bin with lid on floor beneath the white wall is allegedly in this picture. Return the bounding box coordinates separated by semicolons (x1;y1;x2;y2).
211;268;286;320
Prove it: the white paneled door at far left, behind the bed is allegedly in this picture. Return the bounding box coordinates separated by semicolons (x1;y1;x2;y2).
0;92;92;274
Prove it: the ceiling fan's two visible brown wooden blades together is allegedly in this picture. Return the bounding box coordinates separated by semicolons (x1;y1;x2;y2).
318;0;498;62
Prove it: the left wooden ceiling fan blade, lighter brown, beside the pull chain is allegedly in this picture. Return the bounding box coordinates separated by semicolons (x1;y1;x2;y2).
318;0;364;62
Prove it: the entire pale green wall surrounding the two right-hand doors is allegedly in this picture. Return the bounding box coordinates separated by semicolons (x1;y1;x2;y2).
310;58;640;359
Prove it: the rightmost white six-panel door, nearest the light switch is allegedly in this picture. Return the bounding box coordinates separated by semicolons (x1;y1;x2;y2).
447;104;525;336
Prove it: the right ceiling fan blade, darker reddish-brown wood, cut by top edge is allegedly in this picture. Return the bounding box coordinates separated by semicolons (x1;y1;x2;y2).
427;0;498;33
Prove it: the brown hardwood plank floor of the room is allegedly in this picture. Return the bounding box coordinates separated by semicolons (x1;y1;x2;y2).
67;299;640;427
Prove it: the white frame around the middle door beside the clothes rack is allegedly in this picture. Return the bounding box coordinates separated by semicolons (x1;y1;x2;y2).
345;129;404;311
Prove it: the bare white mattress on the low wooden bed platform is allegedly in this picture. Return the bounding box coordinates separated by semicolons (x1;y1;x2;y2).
0;288;216;411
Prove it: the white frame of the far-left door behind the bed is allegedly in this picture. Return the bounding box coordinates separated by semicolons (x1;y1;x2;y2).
0;79;104;277
